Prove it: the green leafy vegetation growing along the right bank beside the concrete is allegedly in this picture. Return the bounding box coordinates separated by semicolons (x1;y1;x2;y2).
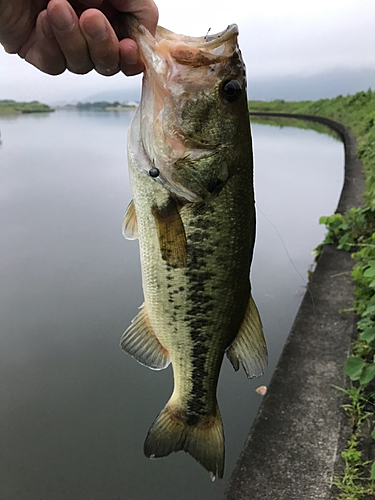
249;89;375;500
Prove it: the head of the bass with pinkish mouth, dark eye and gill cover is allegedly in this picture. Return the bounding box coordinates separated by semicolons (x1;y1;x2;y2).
135;21;251;202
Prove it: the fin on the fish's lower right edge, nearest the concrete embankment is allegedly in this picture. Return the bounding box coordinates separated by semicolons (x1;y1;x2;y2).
227;295;268;378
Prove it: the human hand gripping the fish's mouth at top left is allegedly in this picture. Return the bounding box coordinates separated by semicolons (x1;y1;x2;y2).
0;0;158;76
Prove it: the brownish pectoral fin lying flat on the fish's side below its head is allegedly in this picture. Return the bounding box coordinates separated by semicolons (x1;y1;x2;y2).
152;198;187;267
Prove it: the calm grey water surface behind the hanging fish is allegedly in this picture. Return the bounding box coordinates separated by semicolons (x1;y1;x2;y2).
0;112;344;500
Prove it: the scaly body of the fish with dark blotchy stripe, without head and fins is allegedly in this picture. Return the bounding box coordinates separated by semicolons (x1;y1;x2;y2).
130;158;255;416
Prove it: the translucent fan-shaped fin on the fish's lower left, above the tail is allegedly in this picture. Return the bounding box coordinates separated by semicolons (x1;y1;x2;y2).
121;305;170;370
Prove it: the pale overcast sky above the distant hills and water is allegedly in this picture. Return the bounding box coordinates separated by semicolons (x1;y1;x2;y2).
0;0;375;102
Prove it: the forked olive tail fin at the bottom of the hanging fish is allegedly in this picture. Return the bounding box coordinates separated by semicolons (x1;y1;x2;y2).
144;403;224;479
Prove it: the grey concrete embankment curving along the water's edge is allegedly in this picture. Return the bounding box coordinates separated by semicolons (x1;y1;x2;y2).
225;113;365;500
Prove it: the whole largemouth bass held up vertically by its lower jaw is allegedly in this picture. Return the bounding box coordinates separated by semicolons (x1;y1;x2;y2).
121;20;267;477
